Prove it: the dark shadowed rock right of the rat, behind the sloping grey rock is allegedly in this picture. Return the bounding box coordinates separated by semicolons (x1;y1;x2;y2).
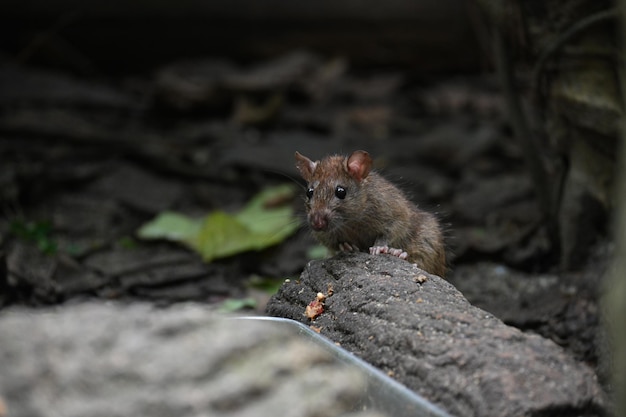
446;260;607;368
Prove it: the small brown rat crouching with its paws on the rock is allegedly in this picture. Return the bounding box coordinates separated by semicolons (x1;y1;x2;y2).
295;150;446;277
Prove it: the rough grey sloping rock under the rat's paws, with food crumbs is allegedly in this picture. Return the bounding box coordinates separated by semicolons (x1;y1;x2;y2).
267;253;607;416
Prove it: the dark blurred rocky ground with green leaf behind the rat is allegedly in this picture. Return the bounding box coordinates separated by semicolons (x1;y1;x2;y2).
0;0;623;408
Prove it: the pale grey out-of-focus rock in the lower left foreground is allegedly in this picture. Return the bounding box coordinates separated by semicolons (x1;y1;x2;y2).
0;303;380;417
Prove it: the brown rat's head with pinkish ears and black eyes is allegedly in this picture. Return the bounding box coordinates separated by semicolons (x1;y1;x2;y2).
296;151;372;232
